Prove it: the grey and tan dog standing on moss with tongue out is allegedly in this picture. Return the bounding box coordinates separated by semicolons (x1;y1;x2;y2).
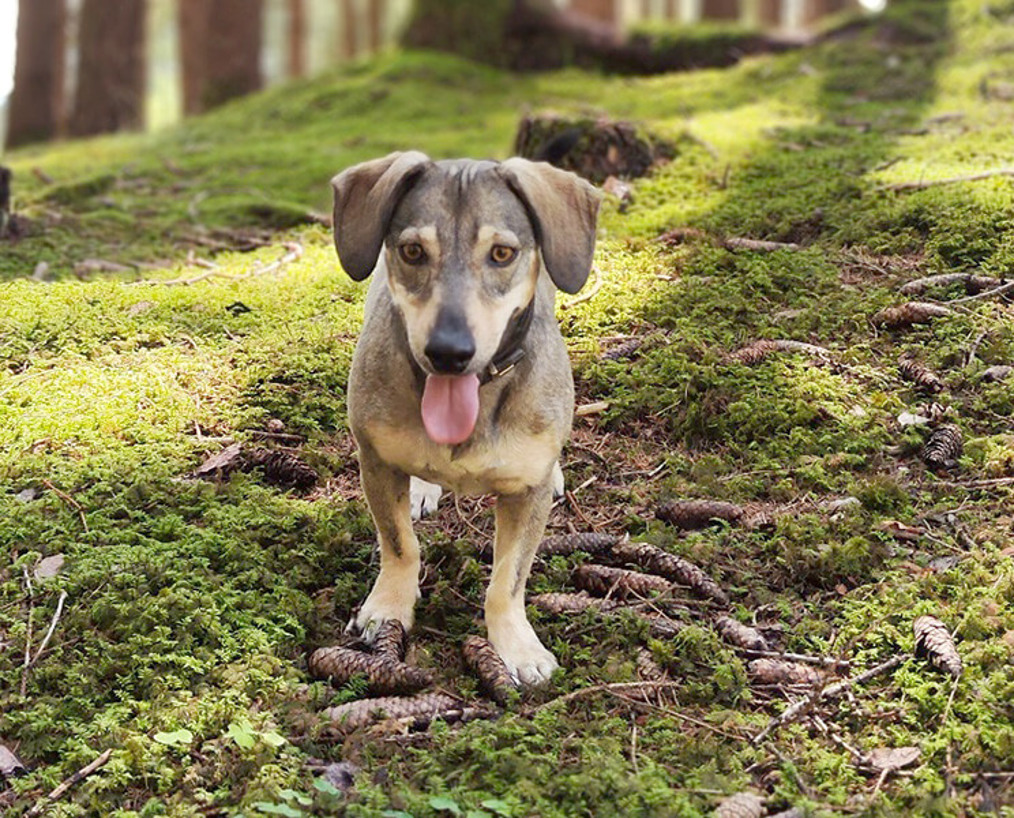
332;151;600;685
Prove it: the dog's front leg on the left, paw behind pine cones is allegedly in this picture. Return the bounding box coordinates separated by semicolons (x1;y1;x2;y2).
349;446;420;642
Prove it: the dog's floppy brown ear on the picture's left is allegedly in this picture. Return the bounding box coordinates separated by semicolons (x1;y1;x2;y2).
331;151;430;281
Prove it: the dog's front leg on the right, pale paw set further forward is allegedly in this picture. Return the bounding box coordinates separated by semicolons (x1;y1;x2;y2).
486;480;558;684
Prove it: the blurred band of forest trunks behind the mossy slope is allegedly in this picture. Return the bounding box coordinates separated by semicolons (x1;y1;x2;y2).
0;0;884;148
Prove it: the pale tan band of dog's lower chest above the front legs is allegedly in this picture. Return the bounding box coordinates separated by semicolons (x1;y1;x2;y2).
370;426;560;495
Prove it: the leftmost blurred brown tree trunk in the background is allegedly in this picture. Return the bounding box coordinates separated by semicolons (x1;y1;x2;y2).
7;0;67;148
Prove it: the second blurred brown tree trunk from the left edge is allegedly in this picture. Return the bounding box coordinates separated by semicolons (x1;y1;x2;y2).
69;0;147;136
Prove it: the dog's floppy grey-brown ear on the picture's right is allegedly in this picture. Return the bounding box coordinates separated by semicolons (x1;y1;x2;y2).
499;157;601;293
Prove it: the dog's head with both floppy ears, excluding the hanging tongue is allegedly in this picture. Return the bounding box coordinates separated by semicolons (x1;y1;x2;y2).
333;153;598;375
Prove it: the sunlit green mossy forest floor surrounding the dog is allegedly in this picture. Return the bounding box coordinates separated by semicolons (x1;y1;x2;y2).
0;0;1014;816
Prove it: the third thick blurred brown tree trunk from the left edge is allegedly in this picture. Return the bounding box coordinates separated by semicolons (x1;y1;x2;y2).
178;0;264;114
